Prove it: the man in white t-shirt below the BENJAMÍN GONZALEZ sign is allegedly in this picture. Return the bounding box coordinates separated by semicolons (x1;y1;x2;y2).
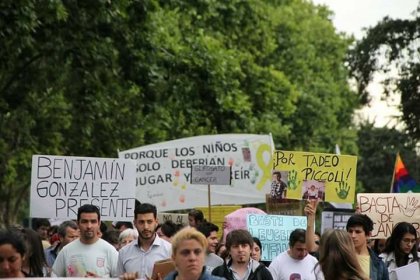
52;204;118;278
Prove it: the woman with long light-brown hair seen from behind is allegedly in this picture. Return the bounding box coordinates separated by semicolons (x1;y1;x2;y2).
318;229;369;280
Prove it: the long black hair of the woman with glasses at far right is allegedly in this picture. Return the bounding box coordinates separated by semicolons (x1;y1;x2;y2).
384;222;419;267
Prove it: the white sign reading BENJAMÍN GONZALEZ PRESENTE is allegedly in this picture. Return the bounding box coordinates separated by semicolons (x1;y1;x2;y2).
30;155;136;221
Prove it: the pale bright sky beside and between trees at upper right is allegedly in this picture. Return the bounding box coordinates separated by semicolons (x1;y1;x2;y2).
312;0;419;127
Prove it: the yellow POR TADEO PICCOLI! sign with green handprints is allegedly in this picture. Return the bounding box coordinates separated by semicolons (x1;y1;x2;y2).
273;151;357;203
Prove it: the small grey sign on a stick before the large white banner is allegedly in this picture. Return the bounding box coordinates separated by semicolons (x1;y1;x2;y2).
191;165;231;185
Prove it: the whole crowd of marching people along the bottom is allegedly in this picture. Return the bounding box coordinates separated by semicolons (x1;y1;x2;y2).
0;200;420;280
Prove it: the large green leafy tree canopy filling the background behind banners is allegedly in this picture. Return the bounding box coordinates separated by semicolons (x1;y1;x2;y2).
0;0;358;224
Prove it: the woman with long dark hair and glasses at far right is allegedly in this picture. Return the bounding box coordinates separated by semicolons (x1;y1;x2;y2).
379;222;420;280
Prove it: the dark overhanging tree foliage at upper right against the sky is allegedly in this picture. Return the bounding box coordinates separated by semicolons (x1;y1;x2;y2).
349;16;420;140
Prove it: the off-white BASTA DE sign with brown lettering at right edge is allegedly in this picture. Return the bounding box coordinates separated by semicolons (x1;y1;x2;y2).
357;193;420;239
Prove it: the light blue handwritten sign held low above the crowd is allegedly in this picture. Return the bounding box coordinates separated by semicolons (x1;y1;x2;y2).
247;214;306;261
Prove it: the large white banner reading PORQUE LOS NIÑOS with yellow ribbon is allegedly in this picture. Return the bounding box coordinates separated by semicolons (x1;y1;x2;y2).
119;134;273;211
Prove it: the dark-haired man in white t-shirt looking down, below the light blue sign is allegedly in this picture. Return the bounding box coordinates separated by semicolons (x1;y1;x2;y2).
268;229;324;280
